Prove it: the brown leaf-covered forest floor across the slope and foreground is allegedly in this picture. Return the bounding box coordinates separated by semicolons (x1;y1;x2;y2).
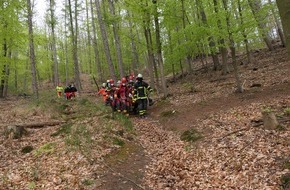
0;48;290;190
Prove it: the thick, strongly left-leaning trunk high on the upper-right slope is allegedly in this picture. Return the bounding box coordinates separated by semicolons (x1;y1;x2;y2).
248;0;274;51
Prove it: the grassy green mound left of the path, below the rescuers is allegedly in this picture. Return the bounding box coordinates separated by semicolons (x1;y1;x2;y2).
23;92;136;166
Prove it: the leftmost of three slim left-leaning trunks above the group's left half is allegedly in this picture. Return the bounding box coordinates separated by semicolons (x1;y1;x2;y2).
90;0;104;81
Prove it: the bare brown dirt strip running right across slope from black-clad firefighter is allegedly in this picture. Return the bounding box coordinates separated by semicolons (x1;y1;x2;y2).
150;82;290;132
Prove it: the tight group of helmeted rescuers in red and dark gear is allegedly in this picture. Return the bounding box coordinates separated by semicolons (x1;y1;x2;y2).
98;74;153;118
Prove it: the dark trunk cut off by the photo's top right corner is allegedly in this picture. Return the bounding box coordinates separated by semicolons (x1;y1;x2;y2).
276;0;290;59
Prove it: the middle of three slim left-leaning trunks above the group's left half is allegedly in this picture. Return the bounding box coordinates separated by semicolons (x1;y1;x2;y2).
95;0;117;81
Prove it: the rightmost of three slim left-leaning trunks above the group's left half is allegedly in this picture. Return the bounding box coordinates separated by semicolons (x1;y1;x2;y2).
109;0;125;77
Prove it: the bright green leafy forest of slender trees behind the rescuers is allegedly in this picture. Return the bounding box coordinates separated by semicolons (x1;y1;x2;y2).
0;0;288;97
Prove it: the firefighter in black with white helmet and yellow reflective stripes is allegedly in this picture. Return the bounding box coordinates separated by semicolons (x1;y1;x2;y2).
133;74;153;118
